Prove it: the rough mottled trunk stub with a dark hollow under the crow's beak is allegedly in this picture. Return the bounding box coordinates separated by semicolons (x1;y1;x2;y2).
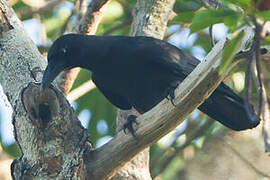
12;83;88;179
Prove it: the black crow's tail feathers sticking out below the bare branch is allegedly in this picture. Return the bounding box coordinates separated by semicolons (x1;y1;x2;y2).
198;83;260;131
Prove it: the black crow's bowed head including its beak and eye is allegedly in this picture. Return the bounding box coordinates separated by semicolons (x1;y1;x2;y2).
42;34;82;89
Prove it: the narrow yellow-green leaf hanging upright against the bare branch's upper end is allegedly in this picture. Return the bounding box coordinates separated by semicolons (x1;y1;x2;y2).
219;31;244;75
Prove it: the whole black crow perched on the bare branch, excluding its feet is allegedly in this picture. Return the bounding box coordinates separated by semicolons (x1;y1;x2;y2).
42;34;259;130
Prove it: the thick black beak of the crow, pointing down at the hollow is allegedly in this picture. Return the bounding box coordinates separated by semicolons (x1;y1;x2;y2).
42;63;62;89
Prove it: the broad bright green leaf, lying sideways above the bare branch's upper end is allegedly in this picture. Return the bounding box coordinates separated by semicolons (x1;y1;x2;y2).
190;9;239;33
